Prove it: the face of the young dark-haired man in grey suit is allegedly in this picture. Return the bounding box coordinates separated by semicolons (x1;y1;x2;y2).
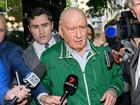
28;14;53;44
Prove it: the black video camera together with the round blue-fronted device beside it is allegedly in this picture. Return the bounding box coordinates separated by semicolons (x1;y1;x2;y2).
105;11;140;51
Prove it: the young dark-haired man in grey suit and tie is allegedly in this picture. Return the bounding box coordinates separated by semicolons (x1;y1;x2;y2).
24;7;60;77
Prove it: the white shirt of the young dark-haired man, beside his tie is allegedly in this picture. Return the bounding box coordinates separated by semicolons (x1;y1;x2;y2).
33;36;56;59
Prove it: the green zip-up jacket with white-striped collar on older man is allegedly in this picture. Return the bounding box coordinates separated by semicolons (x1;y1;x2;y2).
41;40;124;105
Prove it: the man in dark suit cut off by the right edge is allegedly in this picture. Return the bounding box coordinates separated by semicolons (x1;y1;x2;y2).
126;0;140;105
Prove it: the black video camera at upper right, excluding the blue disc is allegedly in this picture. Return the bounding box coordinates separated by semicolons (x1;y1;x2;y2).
117;11;140;39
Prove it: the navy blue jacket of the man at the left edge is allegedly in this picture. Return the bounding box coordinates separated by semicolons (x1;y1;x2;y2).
0;40;45;104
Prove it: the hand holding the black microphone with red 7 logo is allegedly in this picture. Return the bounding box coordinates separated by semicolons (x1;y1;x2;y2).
40;95;66;105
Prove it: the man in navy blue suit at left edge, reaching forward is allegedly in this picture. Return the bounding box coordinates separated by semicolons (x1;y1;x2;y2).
0;15;63;105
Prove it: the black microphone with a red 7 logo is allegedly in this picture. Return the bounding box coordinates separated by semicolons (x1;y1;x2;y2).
59;74;78;105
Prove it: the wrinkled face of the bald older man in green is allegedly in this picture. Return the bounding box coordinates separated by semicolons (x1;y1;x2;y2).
60;10;88;51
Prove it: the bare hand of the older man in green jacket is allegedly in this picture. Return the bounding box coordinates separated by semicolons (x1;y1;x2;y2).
101;90;117;105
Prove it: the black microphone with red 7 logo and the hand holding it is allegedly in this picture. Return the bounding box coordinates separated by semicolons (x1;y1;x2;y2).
40;74;78;105
